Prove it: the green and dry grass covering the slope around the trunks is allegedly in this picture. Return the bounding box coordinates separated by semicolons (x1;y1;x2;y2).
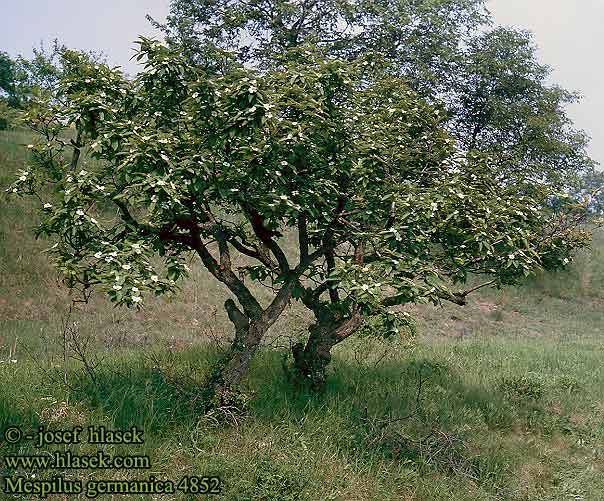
0;127;604;501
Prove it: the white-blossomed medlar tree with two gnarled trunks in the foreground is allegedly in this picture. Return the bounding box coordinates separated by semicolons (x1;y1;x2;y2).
7;39;587;396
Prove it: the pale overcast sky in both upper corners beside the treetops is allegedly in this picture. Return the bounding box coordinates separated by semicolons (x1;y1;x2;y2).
0;0;604;168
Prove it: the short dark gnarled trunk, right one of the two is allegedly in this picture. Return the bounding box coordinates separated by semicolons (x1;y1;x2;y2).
292;313;362;390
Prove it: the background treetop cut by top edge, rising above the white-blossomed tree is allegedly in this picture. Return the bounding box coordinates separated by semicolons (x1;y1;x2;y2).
149;0;487;84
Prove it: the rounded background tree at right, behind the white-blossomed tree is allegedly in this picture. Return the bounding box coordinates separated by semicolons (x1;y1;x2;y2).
448;28;595;187
